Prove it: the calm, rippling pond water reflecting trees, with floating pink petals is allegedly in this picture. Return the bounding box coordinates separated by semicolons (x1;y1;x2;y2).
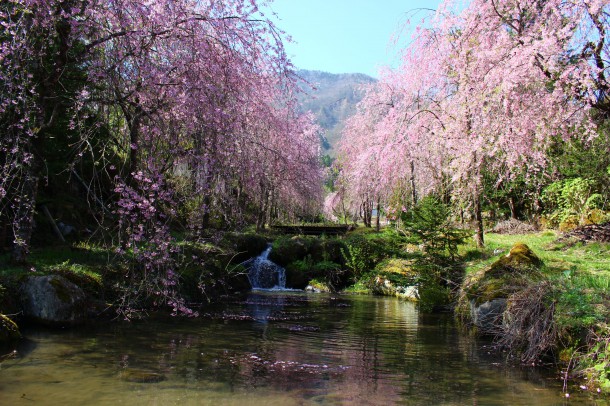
0;292;602;406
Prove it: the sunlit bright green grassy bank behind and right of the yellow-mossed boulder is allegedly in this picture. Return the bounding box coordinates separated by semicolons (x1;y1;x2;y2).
460;231;610;393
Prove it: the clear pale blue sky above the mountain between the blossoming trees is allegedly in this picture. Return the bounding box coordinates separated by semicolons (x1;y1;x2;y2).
270;0;440;77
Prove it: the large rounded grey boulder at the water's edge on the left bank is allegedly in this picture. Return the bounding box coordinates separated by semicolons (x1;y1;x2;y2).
21;275;88;326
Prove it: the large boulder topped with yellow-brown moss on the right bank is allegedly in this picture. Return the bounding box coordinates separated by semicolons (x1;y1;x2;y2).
458;243;543;334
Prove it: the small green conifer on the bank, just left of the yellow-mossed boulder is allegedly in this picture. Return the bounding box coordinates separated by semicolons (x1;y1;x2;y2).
401;196;470;259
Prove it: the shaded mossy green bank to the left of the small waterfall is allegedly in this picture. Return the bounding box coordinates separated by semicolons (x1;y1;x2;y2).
0;233;267;317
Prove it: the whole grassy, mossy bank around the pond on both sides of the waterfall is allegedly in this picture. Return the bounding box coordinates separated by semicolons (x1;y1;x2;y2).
0;229;610;393
